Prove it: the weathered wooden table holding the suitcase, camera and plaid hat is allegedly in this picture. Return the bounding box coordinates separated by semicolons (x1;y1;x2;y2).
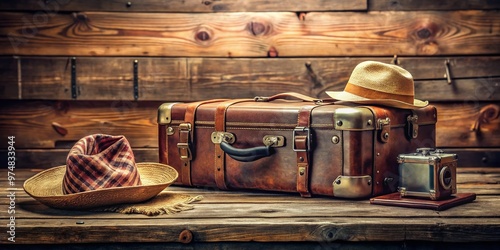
0;168;500;249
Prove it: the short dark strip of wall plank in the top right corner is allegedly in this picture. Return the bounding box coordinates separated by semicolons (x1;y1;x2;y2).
368;0;500;11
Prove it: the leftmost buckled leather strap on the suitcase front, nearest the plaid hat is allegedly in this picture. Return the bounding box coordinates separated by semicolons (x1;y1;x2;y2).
177;99;226;186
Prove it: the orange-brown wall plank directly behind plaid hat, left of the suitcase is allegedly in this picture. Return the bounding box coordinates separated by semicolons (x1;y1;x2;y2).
0;101;161;149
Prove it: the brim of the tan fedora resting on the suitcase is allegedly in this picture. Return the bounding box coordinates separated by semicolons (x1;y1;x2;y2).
326;91;429;109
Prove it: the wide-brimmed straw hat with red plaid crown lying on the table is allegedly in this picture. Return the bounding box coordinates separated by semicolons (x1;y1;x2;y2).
23;134;178;210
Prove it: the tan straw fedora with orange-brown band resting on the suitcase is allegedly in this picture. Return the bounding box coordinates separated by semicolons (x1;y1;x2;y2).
326;61;429;109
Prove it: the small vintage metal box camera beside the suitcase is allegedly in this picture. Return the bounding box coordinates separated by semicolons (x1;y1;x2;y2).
398;148;458;200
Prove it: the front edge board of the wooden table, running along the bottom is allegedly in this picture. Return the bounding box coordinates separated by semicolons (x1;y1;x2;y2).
2;217;500;244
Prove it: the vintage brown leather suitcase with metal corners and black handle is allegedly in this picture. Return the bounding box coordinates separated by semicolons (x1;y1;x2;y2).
158;93;436;198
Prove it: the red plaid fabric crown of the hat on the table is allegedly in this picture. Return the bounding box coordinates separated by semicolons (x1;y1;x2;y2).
63;134;142;194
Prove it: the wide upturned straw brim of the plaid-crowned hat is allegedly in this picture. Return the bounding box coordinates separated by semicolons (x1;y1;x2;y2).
23;162;178;210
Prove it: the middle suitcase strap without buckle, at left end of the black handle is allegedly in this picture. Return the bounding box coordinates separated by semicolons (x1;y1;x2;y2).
214;99;254;190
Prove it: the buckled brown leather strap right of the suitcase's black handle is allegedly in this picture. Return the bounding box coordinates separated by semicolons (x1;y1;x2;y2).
293;104;318;197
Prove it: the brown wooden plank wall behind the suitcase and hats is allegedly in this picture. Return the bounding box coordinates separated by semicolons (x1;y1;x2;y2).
0;0;500;168
